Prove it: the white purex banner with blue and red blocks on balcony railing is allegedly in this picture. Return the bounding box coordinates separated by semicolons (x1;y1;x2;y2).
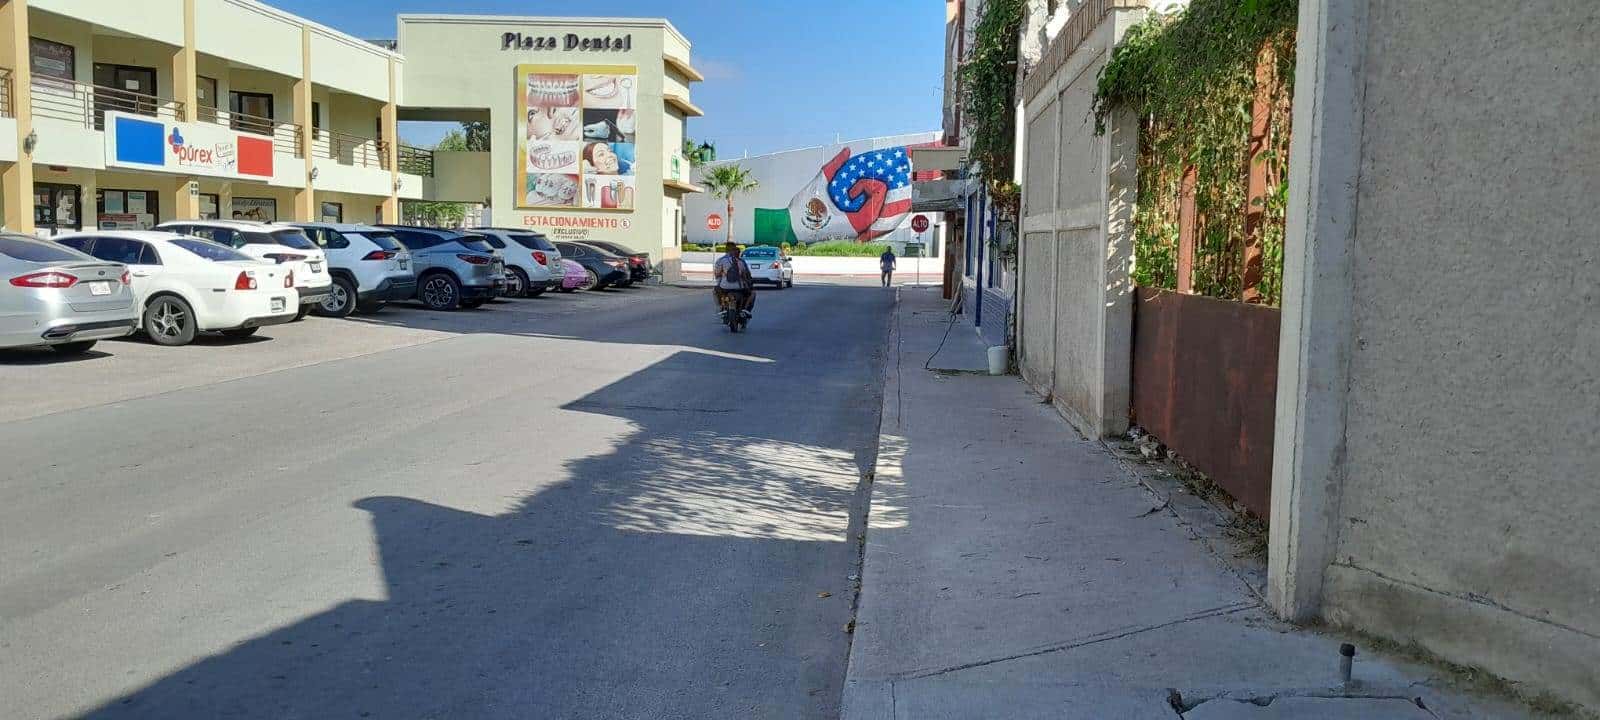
106;112;272;178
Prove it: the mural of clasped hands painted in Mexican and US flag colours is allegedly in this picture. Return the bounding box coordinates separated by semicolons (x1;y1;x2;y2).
789;147;912;243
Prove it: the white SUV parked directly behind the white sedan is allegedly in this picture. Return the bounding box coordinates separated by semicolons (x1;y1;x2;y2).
155;221;333;320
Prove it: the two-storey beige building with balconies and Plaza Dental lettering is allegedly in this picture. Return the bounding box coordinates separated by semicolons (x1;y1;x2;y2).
0;0;701;278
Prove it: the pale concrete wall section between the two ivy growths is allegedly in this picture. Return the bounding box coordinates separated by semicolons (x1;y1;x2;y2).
1018;2;1144;437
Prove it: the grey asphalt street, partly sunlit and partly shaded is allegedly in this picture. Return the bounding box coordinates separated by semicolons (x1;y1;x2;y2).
0;285;893;718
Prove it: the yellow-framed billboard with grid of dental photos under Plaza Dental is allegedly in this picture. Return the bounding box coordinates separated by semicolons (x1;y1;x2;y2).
517;64;638;211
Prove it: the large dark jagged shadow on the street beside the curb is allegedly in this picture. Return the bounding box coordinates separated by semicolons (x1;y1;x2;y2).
88;294;883;718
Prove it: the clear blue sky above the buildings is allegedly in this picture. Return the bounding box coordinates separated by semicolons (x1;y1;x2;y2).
266;0;944;157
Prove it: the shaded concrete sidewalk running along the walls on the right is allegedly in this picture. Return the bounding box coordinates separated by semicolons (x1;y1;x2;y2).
843;288;1531;720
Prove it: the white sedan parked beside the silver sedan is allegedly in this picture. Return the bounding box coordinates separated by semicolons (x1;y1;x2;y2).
54;230;296;346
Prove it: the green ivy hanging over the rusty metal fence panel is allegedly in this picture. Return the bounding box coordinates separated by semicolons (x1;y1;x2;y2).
1094;0;1299;306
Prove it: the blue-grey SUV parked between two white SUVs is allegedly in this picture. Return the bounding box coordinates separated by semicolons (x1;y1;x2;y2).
378;226;506;310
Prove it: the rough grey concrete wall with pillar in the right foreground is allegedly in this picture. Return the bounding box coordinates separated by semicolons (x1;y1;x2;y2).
1270;0;1600;707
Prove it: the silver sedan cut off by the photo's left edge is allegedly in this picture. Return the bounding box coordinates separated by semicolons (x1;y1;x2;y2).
0;234;139;355
